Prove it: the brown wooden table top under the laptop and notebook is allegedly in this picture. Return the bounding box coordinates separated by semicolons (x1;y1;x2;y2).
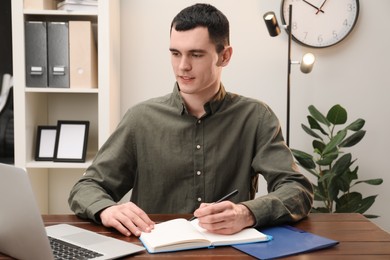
0;214;390;260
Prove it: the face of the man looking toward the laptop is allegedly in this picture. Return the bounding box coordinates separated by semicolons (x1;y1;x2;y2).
169;27;222;96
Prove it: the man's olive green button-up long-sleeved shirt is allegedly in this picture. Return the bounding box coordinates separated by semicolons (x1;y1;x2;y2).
69;84;313;226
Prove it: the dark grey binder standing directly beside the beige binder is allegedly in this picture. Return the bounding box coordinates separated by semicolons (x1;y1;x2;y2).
47;21;69;88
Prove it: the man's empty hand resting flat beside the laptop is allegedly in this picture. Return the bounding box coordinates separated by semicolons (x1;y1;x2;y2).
100;202;154;236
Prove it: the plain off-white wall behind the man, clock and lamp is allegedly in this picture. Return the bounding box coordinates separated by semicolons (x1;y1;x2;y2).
121;0;390;231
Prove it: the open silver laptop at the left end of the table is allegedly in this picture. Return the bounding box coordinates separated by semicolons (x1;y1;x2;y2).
0;163;145;260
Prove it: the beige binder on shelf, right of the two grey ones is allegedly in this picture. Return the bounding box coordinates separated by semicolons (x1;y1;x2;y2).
69;21;98;88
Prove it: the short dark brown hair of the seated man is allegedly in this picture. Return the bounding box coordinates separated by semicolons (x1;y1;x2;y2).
171;4;230;53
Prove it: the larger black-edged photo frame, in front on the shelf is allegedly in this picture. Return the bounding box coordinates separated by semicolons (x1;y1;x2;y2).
54;120;89;162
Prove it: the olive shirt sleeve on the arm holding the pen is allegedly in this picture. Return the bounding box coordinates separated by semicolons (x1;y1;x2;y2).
242;104;313;226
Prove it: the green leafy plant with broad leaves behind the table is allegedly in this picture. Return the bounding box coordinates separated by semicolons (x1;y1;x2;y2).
292;105;383;218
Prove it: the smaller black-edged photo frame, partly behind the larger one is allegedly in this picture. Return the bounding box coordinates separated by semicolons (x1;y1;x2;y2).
35;125;57;161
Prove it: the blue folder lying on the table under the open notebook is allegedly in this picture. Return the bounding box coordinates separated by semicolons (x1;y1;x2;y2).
233;225;339;259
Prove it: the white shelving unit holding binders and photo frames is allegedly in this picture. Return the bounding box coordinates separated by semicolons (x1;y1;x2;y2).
10;0;120;214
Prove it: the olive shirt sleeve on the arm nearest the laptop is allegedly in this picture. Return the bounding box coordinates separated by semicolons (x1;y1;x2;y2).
68;112;136;222
